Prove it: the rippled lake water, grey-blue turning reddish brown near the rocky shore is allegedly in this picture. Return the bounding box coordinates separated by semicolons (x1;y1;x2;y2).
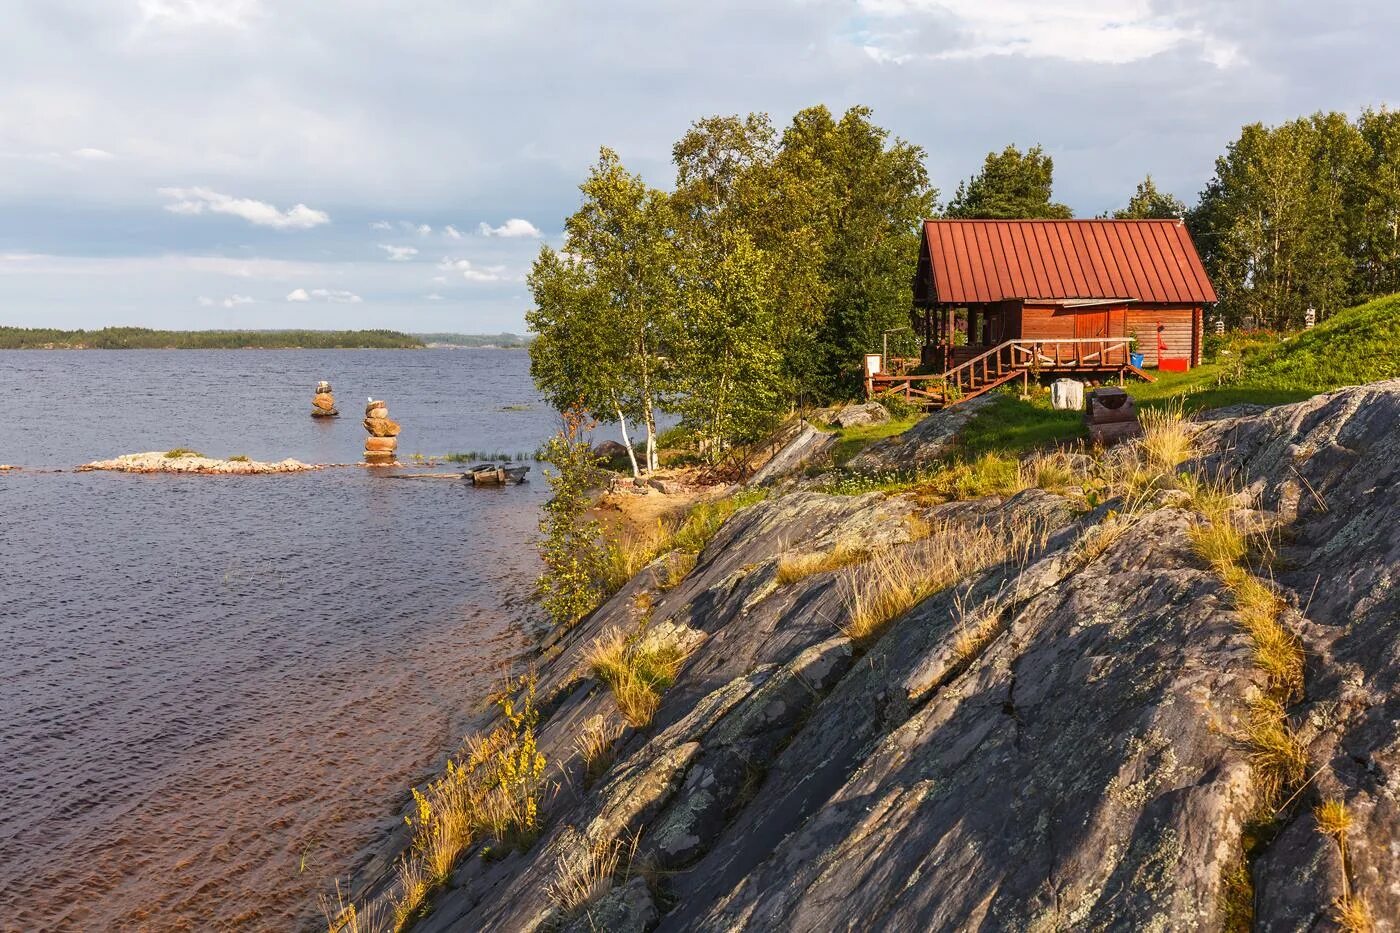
0;350;568;930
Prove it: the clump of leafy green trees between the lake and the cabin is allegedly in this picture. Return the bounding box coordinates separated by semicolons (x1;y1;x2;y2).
528;106;937;467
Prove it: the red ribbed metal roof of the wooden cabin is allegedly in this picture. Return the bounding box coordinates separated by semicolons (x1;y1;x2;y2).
924;220;1215;304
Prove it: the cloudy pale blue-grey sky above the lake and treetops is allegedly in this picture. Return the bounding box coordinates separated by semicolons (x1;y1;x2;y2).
0;0;1400;333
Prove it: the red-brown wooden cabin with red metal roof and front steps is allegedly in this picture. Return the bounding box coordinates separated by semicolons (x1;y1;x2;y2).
867;220;1217;406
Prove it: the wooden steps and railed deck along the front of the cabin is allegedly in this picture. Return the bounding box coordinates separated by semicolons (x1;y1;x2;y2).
865;338;1154;409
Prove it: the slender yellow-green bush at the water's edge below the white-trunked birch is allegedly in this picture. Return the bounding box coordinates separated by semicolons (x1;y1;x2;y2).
535;403;605;628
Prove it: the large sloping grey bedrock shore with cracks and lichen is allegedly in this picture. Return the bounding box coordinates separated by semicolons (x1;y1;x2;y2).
347;381;1400;933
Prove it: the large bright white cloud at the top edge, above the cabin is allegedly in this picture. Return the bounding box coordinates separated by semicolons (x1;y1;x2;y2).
860;0;1235;66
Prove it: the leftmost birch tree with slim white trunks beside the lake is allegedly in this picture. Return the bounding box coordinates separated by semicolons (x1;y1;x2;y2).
526;148;679;469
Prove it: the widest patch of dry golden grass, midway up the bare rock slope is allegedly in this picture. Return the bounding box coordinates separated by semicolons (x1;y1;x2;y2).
841;520;1046;646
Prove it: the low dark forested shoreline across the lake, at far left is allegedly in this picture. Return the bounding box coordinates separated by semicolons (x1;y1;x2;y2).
0;326;424;344
